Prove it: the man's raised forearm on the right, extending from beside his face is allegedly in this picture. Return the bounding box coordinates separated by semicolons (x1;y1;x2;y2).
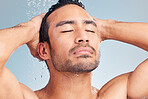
98;20;148;51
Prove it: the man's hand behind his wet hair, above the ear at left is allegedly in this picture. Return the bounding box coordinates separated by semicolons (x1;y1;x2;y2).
27;13;45;60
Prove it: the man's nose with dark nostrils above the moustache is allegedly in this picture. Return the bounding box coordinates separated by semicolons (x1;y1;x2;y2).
75;32;89;44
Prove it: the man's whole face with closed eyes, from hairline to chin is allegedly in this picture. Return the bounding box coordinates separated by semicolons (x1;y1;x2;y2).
47;5;100;73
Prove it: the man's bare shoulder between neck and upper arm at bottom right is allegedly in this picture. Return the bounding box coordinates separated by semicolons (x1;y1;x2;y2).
98;73;130;99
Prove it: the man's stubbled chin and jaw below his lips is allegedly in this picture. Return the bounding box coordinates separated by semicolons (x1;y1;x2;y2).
53;55;99;73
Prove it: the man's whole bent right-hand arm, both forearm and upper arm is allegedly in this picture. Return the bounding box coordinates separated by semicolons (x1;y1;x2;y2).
96;19;148;99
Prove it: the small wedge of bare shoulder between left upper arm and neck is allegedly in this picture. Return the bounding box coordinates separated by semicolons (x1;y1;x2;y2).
20;83;39;99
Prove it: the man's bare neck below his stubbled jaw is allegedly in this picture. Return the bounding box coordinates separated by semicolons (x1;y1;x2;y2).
45;71;93;99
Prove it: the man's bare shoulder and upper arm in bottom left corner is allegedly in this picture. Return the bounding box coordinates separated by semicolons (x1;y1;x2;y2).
0;67;38;99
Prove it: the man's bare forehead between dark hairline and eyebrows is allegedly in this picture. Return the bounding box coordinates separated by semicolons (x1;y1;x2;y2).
47;4;93;26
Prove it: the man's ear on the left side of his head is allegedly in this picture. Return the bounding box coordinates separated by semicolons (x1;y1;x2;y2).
37;42;50;60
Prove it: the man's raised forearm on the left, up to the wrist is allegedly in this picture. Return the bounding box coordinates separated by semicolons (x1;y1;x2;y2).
0;23;33;68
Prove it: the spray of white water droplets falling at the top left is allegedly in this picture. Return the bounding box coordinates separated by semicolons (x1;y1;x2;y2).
26;0;57;19
